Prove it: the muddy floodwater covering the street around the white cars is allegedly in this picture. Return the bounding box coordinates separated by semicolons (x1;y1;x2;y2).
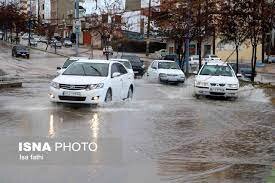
0;45;275;183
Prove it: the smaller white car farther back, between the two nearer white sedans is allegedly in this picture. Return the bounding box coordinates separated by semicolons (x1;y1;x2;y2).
147;60;185;83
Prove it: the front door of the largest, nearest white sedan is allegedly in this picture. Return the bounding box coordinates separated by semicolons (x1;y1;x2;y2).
111;63;123;100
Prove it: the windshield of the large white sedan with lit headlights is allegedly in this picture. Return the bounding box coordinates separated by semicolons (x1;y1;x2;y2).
63;62;109;77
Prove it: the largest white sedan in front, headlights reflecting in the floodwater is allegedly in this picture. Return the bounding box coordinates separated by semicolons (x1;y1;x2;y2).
49;59;134;104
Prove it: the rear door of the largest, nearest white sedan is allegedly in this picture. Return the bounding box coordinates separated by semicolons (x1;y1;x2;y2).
118;63;132;99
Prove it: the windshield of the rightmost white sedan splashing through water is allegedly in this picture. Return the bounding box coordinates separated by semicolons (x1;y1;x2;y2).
200;65;233;77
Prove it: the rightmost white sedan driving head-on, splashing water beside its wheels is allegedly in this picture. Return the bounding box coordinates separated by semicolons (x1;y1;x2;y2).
195;62;242;98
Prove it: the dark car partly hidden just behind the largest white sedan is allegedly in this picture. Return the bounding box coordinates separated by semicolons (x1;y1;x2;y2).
121;55;145;76
